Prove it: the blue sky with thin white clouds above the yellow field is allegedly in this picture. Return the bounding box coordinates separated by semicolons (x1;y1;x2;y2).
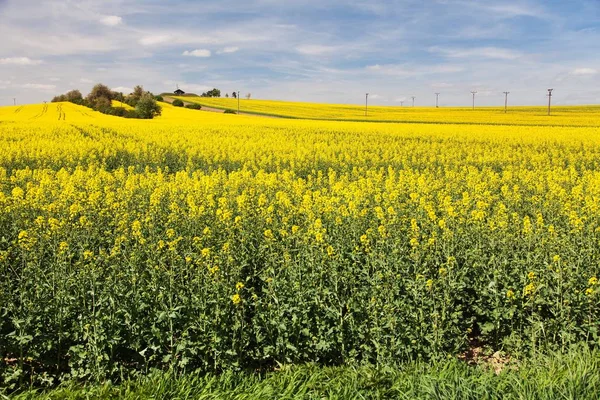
0;0;600;106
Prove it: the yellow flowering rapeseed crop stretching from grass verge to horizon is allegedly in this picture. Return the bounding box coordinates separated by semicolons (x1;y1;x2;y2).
0;99;600;382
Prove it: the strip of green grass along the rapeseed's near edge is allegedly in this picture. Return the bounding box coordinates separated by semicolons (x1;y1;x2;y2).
9;349;600;400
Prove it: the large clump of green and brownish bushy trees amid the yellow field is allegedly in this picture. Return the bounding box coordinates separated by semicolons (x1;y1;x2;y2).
52;83;162;119
